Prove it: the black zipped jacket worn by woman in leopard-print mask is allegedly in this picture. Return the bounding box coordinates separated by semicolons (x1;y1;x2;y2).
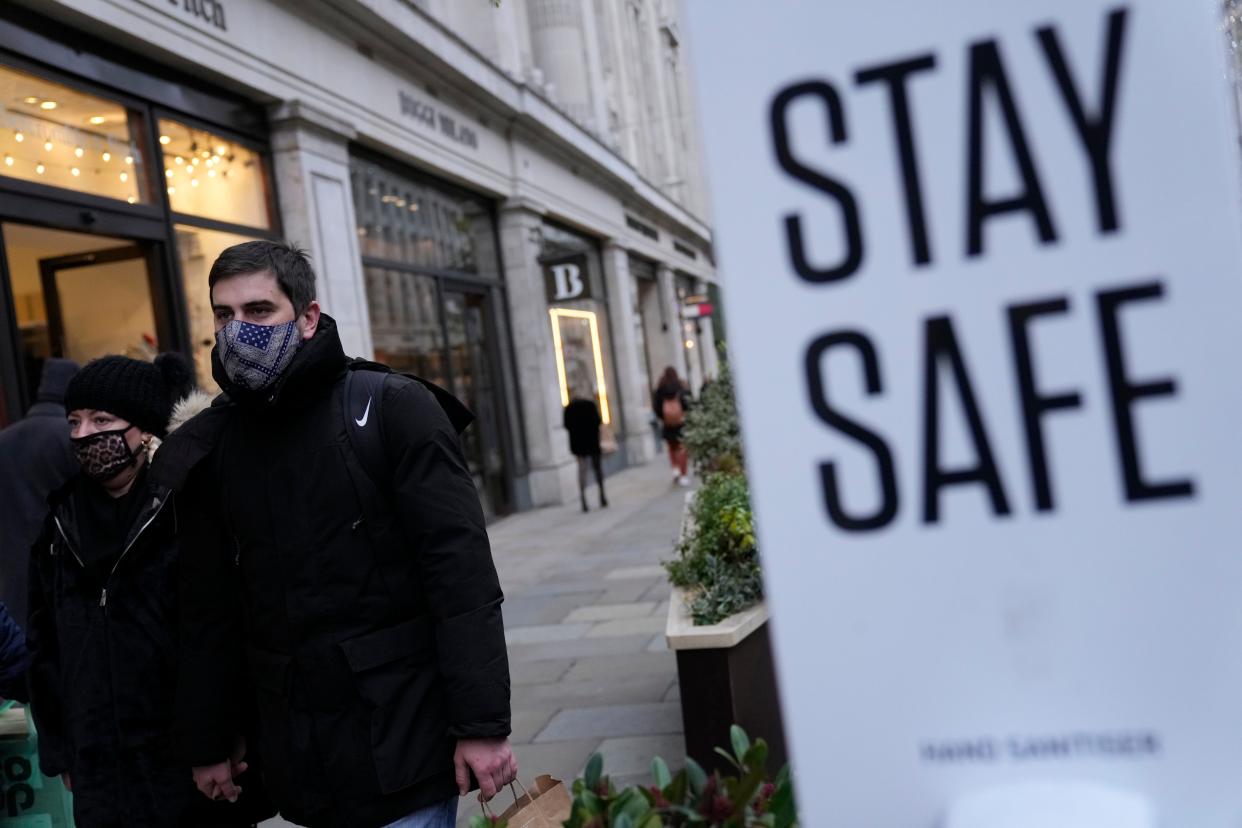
27;436;273;828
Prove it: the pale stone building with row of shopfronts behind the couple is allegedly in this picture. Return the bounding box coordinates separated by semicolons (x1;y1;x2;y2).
0;0;715;515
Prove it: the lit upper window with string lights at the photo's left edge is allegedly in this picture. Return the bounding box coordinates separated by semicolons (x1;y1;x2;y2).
0;67;150;204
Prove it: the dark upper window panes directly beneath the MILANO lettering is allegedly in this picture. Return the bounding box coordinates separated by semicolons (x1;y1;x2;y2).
351;160;499;279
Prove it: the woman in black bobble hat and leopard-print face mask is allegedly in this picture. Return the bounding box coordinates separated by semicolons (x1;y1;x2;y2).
27;355;268;828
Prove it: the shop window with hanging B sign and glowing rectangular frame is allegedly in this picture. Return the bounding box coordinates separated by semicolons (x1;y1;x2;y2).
539;223;619;453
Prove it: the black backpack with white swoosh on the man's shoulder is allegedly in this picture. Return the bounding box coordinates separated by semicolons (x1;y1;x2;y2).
340;359;474;490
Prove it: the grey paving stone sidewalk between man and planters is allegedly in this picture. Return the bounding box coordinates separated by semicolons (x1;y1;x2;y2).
458;458;687;822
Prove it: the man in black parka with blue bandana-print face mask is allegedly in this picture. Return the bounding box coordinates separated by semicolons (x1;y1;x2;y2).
178;241;517;828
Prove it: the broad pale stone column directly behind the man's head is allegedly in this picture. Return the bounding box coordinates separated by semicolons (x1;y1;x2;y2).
271;101;374;359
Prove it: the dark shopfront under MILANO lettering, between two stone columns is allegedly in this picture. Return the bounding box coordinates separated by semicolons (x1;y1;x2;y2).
350;150;524;516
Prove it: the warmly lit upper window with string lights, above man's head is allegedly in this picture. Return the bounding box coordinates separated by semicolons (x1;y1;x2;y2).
159;118;272;230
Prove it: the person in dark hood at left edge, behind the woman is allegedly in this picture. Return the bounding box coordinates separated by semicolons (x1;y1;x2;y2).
0;359;78;626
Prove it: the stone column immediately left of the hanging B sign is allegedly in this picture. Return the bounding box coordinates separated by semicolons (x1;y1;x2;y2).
501;200;578;506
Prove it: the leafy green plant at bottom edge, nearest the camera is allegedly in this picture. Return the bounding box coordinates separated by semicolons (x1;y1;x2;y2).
565;725;797;828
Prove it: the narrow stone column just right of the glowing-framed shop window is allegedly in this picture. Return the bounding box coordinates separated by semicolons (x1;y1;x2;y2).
604;240;656;466
